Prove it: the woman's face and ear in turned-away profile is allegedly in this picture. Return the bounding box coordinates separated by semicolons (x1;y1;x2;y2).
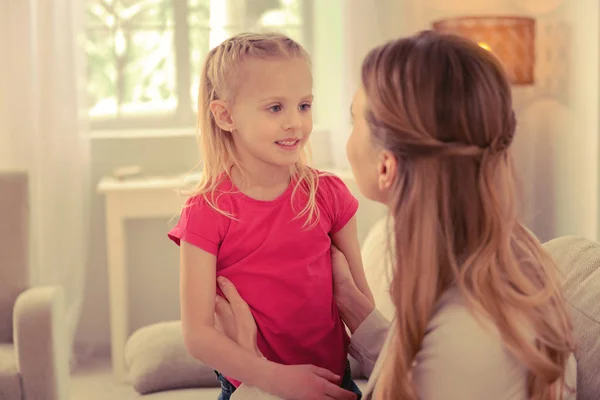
346;86;396;204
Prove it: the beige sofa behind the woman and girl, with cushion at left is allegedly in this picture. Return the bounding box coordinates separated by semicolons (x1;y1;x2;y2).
125;219;600;400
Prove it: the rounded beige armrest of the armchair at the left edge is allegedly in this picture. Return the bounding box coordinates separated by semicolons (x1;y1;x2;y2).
13;287;69;400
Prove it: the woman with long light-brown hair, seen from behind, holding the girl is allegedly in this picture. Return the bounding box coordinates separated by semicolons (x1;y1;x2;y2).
212;32;576;400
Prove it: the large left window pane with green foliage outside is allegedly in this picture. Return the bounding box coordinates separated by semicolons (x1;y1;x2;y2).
85;0;177;119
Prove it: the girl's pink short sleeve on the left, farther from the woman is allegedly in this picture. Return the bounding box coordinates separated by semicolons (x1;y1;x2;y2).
168;196;227;255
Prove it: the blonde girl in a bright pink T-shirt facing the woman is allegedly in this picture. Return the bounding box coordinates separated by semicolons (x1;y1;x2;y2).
164;34;373;400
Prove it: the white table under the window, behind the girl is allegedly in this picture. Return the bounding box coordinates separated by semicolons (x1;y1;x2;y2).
97;170;386;382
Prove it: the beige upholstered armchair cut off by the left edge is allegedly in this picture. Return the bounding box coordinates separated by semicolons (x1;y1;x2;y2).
0;171;69;400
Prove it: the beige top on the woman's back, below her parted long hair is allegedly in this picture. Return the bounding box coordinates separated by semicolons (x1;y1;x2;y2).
414;288;527;399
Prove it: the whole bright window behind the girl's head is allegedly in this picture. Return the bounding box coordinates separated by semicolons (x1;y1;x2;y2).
85;0;311;130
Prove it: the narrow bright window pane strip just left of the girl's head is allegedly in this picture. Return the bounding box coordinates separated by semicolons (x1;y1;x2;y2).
188;0;210;111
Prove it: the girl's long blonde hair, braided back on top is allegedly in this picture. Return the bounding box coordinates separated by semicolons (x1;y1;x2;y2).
186;33;319;226
